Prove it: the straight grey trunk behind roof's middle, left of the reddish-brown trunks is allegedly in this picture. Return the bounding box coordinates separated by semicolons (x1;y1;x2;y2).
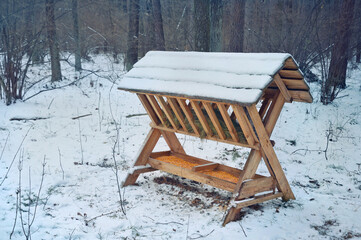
194;0;209;52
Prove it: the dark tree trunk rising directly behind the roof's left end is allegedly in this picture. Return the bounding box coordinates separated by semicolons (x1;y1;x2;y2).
152;0;165;50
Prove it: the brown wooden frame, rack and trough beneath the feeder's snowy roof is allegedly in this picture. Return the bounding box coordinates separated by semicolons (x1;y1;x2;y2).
119;52;312;225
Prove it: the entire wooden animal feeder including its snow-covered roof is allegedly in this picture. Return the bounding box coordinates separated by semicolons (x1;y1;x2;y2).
119;52;312;225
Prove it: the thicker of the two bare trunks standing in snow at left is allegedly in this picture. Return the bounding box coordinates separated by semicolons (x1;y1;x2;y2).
45;0;61;82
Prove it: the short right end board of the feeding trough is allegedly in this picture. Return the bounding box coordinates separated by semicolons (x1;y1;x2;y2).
236;177;276;200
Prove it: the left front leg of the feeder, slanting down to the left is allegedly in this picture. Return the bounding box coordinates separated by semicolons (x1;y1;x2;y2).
123;128;161;187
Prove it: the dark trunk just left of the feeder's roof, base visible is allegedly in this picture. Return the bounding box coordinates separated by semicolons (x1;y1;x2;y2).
125;0;139;71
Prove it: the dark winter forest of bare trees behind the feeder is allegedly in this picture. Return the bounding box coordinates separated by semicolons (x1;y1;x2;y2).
0;0;361;104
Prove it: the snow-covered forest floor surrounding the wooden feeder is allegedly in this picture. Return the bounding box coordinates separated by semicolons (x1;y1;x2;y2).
0;55;361;239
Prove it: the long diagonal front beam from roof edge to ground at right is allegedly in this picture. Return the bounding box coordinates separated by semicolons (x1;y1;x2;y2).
247;106;295;200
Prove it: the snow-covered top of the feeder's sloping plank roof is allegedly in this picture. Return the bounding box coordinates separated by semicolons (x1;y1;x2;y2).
119;51;310;105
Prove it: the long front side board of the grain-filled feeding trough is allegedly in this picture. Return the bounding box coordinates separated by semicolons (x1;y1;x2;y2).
148;158;236;192
